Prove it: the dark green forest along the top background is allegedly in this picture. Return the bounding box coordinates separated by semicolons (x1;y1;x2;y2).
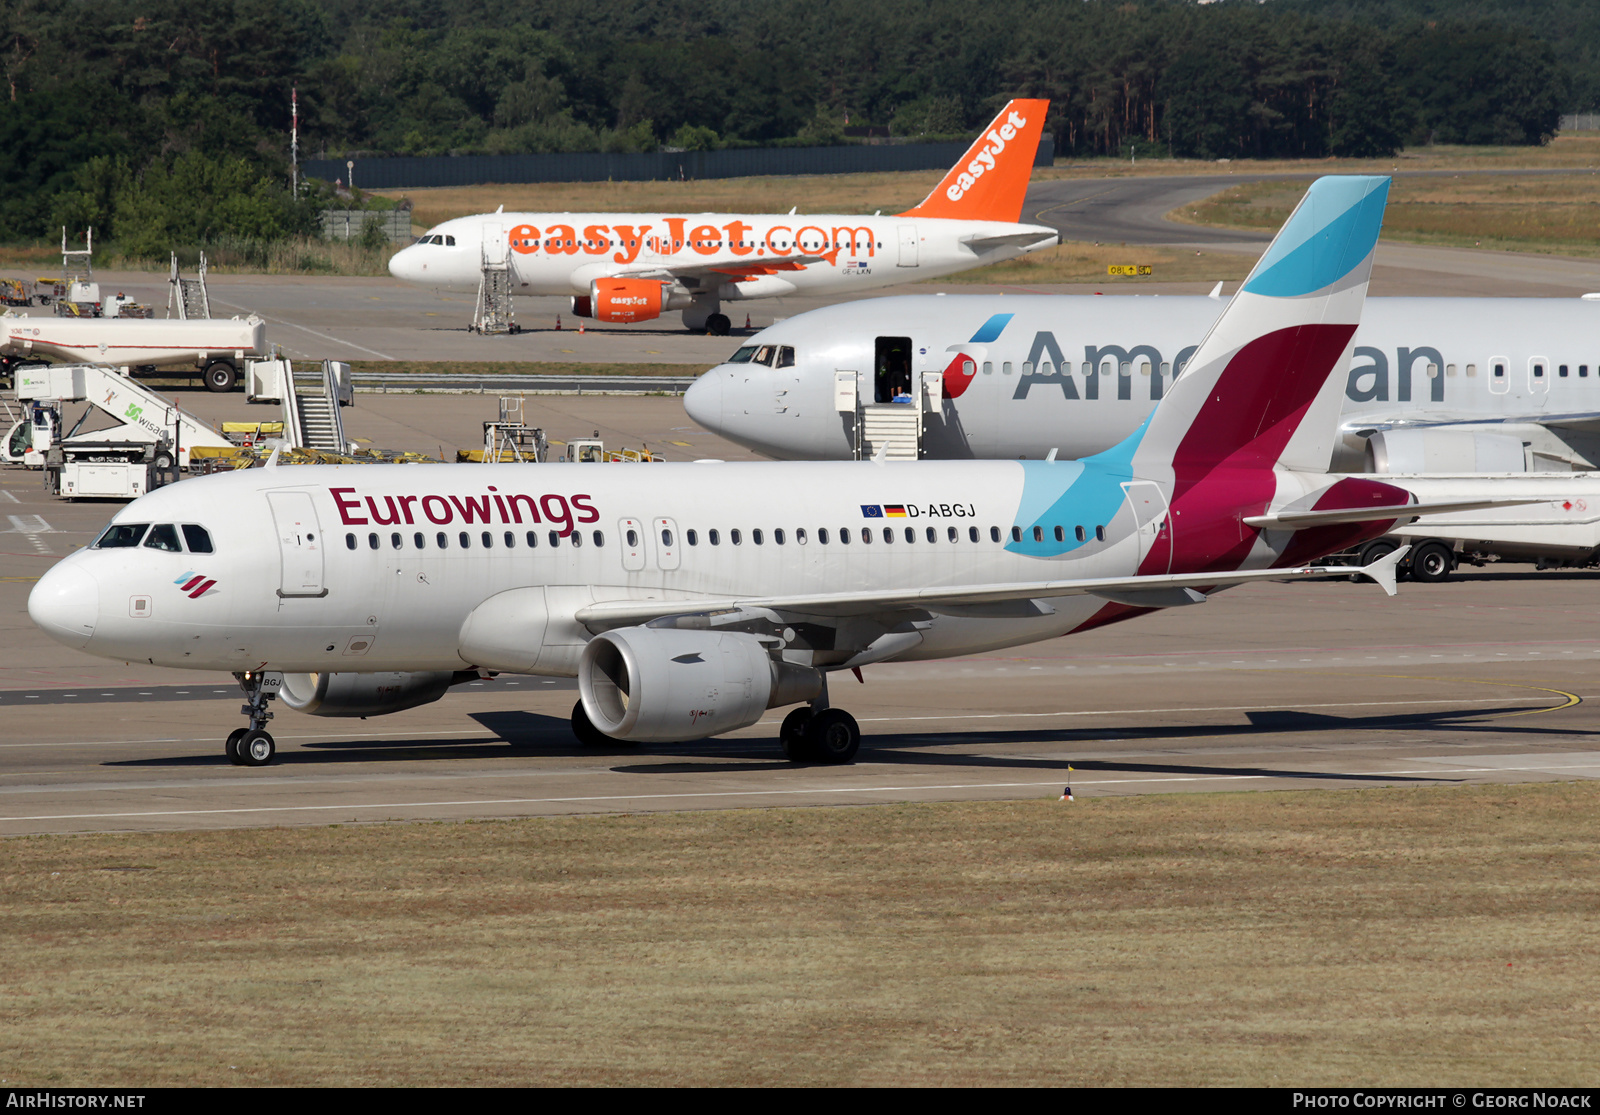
0;0;1574;245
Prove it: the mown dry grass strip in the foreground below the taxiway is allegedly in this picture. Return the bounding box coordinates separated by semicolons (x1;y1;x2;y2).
0;782;1600;1088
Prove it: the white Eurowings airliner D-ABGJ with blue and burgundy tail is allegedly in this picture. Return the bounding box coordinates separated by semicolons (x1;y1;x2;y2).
29;178;1482;765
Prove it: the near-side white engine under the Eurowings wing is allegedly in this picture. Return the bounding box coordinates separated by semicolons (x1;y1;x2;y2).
578;627;822;744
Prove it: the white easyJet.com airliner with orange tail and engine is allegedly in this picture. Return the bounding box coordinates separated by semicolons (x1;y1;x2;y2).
389;101;1059;336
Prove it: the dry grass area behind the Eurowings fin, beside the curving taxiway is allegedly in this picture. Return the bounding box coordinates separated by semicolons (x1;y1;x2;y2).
1178;173;1600;256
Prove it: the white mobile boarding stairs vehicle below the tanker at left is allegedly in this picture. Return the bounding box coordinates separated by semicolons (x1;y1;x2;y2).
0;365;234;499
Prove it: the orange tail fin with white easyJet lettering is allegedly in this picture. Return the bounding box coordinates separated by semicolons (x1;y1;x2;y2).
901;101;1050;224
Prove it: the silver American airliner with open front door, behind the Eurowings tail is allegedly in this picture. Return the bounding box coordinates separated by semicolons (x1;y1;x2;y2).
683;294;1600;474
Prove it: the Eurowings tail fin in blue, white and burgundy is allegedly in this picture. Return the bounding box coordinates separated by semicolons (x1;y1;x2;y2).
1133;176;1389;488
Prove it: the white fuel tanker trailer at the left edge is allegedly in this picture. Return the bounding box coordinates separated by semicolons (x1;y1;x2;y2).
0;314;272;392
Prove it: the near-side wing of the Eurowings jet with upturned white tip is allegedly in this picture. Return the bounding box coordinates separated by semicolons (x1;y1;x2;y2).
576;547;1410;630
